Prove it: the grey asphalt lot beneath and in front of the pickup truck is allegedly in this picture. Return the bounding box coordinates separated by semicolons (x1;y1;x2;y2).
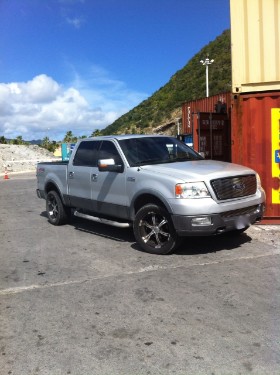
0;173;280;375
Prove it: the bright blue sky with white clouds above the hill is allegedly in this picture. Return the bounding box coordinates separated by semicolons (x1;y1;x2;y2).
0;0;230;140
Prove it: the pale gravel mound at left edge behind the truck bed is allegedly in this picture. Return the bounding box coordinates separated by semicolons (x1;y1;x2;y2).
0;144;59;175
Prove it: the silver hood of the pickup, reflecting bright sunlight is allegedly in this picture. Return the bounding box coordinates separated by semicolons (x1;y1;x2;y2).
141;160;255;181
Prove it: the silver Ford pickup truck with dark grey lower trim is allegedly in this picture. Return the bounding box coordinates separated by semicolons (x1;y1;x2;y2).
37;135;265;254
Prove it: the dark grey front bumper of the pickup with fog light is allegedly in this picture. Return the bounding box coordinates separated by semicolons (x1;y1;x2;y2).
172;204;264;236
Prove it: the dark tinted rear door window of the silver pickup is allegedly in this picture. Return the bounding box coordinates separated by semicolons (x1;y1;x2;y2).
73;141;100;167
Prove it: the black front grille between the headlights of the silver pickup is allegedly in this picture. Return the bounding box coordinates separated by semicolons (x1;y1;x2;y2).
211;174;257;200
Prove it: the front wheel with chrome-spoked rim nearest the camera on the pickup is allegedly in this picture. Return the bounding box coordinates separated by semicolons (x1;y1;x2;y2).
133;204;180;254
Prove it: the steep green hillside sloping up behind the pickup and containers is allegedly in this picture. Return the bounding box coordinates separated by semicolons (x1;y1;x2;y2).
101;30;231;135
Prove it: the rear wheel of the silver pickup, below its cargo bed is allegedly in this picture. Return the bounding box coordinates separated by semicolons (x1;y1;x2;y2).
46;190;71;225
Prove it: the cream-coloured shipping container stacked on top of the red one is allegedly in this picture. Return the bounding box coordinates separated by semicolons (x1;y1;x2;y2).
230;0;280;93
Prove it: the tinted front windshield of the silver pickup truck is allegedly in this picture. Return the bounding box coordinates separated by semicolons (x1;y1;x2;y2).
119;137;203;167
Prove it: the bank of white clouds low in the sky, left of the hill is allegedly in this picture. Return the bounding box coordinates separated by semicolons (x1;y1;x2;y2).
0;70;149;140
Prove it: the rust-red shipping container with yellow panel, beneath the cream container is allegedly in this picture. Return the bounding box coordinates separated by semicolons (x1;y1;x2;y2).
231;91;280;224
